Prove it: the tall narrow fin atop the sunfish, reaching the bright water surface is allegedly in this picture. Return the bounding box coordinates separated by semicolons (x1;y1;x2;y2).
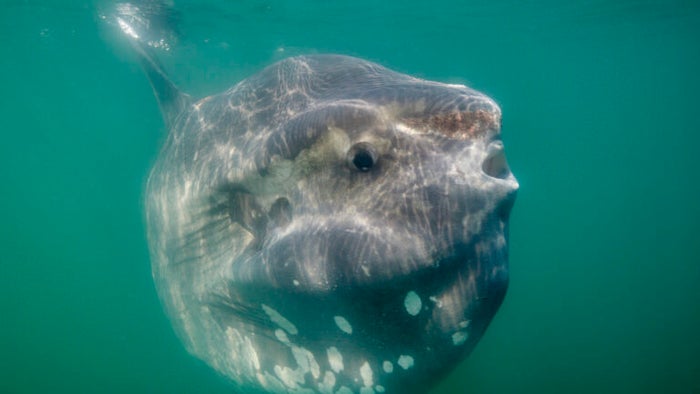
115;0;192;128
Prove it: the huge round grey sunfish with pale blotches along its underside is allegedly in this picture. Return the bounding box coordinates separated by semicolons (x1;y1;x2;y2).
117;6;518;394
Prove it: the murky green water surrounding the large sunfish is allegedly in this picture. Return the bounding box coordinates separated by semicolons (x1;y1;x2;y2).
0;0;700;394
